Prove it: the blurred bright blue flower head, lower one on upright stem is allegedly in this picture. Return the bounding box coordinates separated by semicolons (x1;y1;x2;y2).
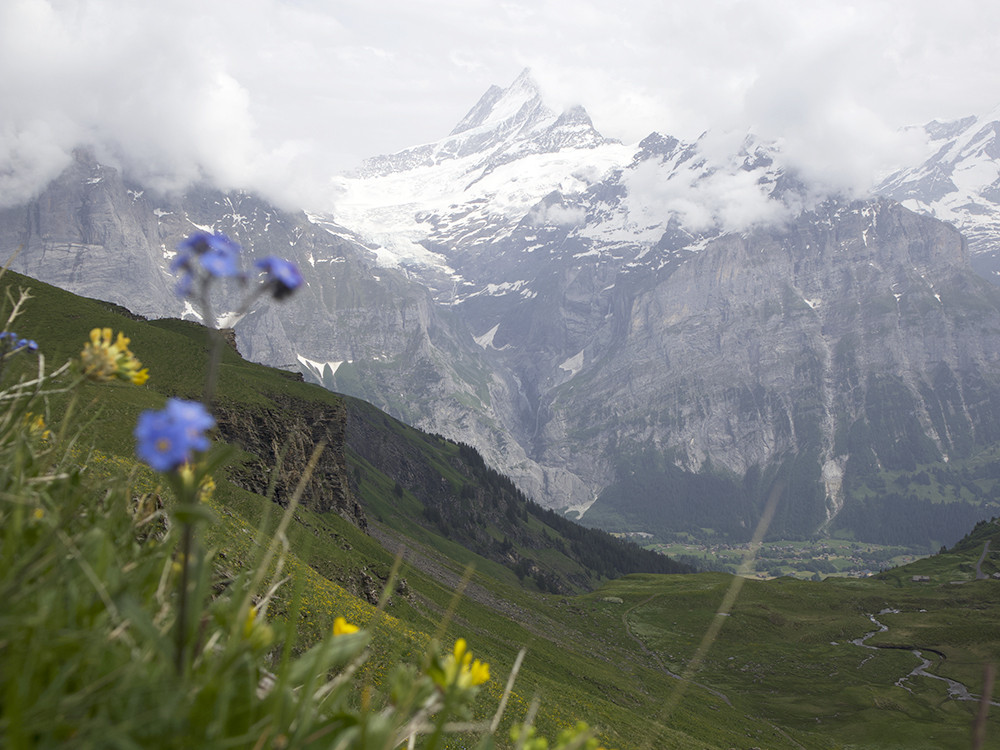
134;398;215;471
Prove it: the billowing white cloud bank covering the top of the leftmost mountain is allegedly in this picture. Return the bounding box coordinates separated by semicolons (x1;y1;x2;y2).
0;0;261;202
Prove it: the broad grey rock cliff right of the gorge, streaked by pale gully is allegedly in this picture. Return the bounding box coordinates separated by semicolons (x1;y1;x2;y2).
540;201;1000;531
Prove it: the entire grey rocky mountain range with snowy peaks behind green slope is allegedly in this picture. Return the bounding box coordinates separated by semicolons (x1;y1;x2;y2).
0;71;1000;545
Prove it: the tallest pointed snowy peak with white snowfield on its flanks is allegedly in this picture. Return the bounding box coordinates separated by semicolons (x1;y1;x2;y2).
325;70;634;276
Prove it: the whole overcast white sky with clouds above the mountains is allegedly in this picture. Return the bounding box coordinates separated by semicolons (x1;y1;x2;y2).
0;0;1000;207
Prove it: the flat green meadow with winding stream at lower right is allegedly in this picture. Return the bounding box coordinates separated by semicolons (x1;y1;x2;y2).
584;561;1000;750
